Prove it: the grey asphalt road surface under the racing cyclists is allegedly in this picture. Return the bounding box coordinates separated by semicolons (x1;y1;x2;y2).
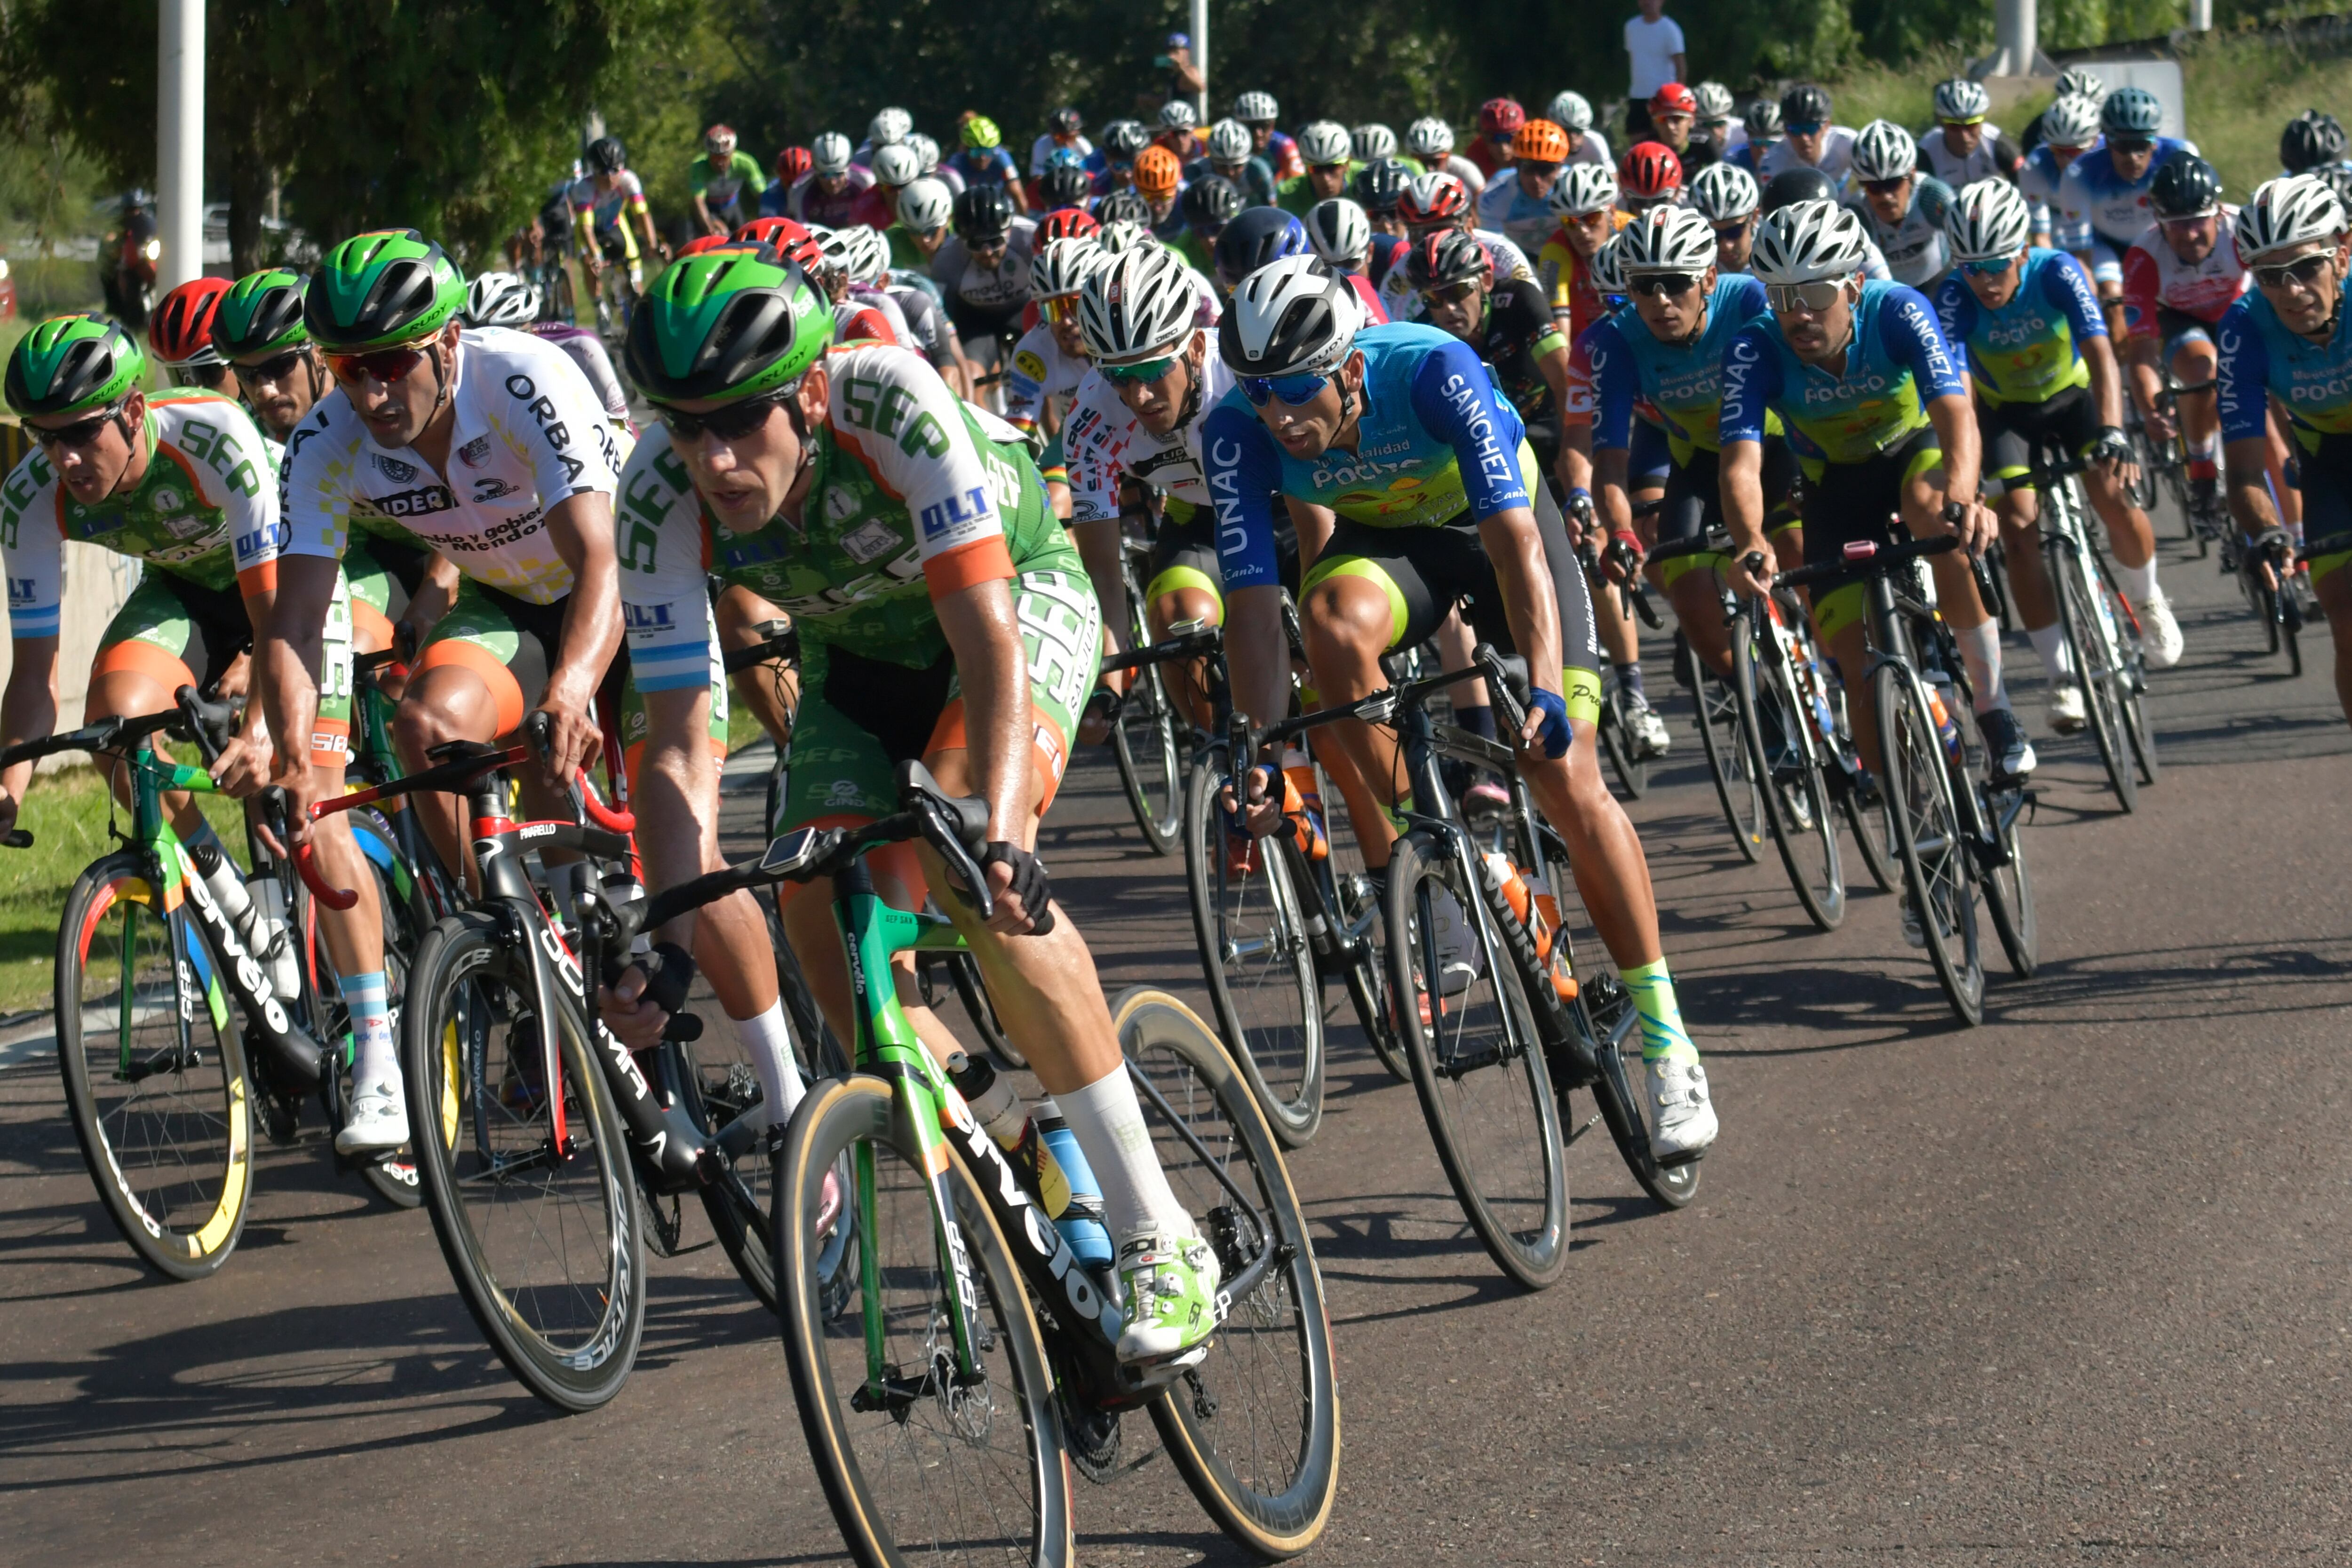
0;505;2352;1568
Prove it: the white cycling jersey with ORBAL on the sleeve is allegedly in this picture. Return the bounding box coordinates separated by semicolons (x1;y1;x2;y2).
280;327;621;604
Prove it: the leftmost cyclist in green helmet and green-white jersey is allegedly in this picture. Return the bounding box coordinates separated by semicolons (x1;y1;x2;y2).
0;315;376;1154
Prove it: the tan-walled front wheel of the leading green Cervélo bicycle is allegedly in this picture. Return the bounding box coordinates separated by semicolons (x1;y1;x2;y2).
771;1075;1077;1568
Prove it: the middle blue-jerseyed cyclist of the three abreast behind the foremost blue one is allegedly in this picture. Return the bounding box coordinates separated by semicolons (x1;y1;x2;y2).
1719;202;2034;822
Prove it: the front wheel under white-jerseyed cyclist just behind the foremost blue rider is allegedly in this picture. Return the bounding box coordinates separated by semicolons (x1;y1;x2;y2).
1183;745;1324;1150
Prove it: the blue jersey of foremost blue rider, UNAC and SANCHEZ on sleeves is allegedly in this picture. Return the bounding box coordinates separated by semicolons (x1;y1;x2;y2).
1202;325;1534;592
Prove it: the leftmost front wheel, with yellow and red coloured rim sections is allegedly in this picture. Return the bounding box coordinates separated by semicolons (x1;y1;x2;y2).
52;849;254;1279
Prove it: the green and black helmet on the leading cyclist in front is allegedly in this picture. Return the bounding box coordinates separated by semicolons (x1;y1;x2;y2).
628;247;833;402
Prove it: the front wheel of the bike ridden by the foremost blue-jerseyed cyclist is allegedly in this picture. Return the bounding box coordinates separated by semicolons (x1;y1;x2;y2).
1388;832;1569;1290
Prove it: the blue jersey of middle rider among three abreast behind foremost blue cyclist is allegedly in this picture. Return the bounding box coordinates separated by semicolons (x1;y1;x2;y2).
1719;282;1962;463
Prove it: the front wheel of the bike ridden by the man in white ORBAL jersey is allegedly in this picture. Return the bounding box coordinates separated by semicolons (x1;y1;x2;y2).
400;910;647;1410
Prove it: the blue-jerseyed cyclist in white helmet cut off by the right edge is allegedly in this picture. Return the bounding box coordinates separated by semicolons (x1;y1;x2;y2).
2216;174;2352;719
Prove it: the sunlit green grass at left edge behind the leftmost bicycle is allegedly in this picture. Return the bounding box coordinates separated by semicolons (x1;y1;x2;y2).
0;769;245;1013
